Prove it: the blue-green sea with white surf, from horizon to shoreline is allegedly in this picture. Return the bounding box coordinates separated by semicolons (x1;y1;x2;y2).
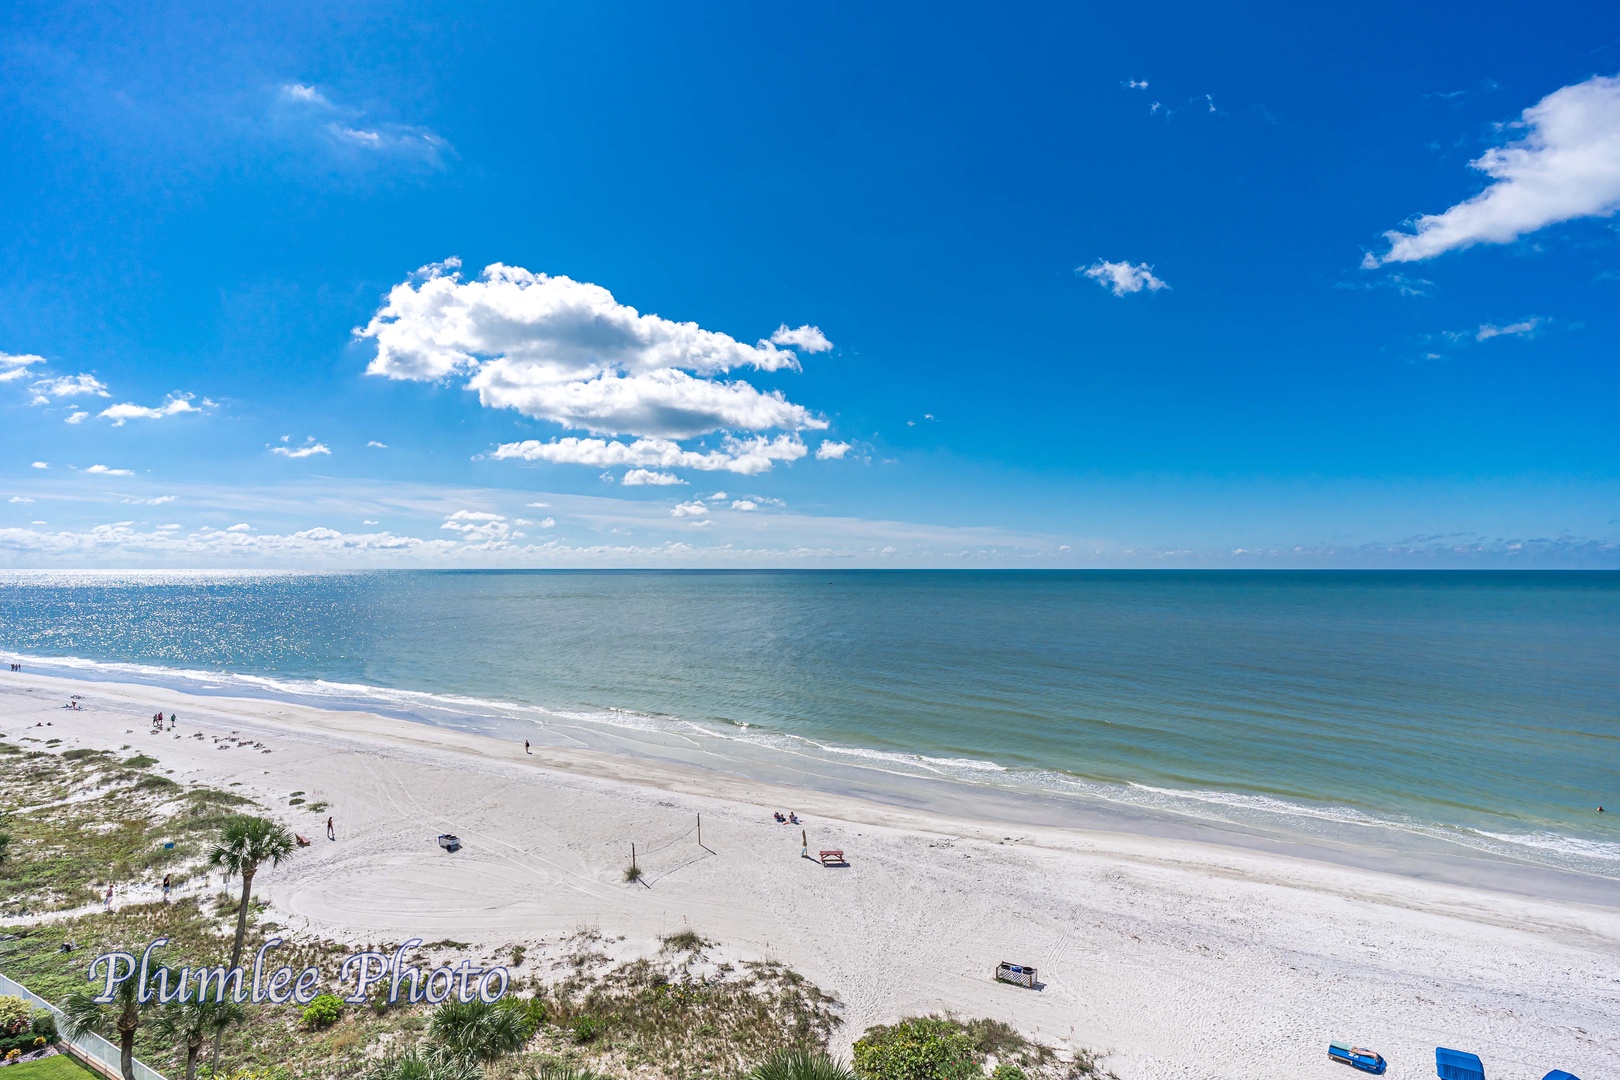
0;572;1620;879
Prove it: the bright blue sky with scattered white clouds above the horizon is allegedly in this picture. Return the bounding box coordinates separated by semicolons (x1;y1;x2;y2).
0;3;1620;567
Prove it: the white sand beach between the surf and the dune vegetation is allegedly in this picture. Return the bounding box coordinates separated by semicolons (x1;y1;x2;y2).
0;672;1620;1080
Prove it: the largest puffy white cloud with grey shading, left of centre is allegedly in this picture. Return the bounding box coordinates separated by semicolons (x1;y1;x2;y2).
355;259;826;439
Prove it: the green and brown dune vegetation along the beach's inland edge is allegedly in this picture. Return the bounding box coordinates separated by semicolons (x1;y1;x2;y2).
0;742;1108;1080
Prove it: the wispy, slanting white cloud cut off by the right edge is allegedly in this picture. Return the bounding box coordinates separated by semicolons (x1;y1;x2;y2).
1362;76;1620;269
